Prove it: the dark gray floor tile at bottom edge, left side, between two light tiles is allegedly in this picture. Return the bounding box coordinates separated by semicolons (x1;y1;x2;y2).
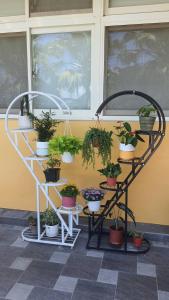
27;287;71;300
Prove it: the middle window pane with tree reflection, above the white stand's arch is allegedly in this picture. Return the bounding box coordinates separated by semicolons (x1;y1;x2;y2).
32;32;91;109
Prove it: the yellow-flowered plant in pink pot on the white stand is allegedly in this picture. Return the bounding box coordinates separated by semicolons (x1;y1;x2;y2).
60;184;79;208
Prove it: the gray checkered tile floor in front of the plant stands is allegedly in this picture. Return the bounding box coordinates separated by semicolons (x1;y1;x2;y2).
0;225;169;300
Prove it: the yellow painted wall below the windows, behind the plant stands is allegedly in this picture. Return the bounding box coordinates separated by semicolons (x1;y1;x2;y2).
0;120;169;225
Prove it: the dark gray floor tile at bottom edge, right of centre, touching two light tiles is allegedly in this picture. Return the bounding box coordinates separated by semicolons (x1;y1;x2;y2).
115;272;158;300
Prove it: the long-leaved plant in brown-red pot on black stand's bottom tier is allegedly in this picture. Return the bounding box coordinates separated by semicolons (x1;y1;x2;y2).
109;202;136;246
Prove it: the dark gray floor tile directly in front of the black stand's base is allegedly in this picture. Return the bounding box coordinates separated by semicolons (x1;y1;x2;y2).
102;252;137;273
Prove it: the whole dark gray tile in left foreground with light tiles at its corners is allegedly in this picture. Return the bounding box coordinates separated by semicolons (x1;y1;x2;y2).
19;261;63;288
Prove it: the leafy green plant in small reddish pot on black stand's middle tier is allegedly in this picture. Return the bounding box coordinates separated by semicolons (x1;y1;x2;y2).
98;163;121;186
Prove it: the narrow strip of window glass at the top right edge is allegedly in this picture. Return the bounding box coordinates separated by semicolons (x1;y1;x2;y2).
109;0;168;7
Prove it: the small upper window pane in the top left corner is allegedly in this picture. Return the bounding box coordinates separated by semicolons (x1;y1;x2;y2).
0;0;25;17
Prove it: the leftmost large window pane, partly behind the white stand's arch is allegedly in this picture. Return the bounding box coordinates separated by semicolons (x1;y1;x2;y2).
0;34;28;111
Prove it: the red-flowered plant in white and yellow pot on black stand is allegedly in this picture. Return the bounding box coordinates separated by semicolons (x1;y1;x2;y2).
114;121;144;160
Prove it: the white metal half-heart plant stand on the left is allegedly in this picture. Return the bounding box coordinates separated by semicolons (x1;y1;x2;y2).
5;91;82;247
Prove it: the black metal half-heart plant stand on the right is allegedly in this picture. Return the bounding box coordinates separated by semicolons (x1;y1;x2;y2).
83;90;166;254
